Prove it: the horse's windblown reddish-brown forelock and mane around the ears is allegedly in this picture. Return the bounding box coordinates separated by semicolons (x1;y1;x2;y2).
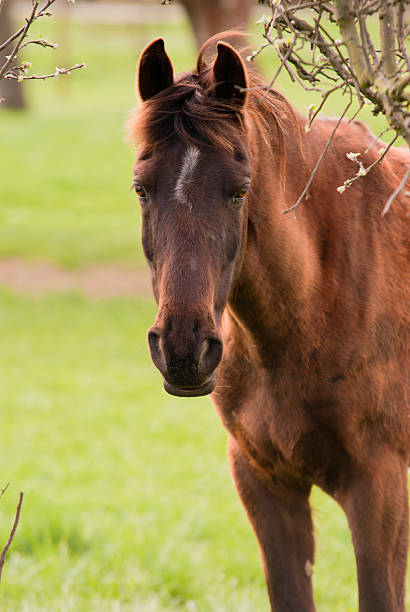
129;32;297;161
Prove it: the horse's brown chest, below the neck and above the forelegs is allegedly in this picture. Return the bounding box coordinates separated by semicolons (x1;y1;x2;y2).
214;384;347;491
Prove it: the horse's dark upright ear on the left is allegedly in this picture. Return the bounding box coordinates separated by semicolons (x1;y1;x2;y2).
137;38;174;102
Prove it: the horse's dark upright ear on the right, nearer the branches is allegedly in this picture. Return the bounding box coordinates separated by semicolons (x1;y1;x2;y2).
213;42;248;107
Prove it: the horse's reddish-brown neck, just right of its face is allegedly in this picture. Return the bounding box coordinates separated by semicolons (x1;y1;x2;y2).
232;110;315;334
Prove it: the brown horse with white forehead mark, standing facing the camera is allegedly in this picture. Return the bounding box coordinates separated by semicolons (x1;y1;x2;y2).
131;34;410;612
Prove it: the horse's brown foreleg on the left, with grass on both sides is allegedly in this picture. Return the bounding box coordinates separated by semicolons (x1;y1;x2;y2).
228;439;315;612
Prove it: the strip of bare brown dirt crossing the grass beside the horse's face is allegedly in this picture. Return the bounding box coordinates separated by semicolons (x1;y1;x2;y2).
0;257;152;299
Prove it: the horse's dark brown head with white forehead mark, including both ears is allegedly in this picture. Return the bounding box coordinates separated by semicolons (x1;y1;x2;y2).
134;39;250;397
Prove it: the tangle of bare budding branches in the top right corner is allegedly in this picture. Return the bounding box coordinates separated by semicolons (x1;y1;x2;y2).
253;0;410;146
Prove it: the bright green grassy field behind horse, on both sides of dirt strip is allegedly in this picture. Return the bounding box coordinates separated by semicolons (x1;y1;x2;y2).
0;10;410;612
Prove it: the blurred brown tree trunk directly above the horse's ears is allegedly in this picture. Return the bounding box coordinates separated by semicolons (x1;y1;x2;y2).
181;0;255;47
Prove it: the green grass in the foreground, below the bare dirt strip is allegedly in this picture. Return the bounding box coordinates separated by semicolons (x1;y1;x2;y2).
0;291;410;612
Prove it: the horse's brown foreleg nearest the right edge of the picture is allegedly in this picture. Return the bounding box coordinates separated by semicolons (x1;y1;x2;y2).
339;452;408;612
